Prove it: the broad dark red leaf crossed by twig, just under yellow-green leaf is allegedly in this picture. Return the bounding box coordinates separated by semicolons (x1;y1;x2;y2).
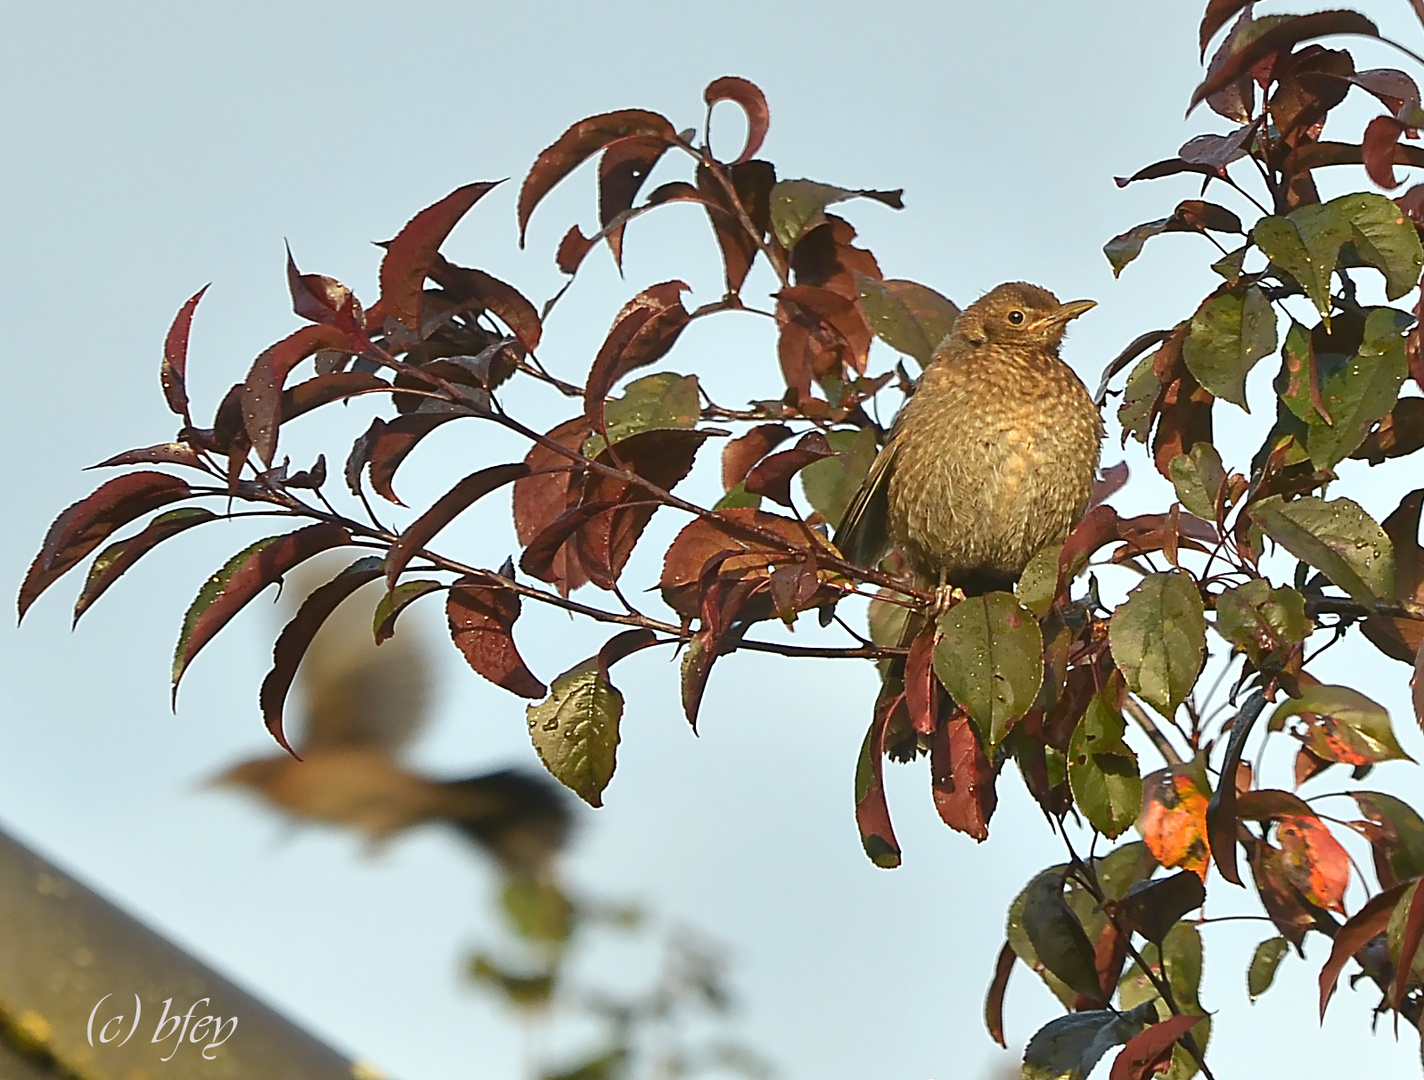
574;429;708;588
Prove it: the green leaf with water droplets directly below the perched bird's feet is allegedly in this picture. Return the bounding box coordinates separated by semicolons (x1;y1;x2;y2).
934;593;1044;757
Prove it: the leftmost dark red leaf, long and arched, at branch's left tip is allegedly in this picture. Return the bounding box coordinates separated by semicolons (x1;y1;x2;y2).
19;472;192;620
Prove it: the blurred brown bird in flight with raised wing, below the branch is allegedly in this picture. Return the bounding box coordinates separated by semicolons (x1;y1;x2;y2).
212;560;572;876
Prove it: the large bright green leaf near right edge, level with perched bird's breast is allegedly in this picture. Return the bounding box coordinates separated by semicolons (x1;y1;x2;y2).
1302;308;1414;469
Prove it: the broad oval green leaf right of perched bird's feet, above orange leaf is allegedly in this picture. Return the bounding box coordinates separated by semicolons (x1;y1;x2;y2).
1108;570;1206;717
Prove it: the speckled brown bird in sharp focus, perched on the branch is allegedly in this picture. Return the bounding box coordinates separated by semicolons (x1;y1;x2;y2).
836;282;1102;596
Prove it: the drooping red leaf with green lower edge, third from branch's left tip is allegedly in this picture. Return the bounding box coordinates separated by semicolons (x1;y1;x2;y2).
172;521;350;701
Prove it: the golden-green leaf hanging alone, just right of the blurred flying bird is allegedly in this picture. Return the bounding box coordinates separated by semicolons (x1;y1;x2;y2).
527;660;624;806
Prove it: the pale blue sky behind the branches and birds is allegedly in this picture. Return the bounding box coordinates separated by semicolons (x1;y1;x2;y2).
0;0;1424;1080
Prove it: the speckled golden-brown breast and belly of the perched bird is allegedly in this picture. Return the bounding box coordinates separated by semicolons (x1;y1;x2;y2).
889;346;1102;583
